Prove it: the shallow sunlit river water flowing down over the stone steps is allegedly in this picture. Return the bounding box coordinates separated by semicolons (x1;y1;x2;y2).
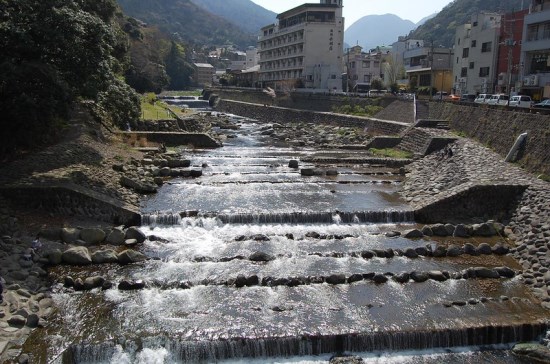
28;113;546;363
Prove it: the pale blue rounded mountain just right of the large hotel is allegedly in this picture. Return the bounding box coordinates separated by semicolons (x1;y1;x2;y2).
344;14;416;50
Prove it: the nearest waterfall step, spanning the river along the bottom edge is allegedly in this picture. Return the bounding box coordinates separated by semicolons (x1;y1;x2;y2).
62;320;548;363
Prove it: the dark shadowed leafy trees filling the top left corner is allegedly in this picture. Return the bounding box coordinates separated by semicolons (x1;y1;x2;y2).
0;0;139;155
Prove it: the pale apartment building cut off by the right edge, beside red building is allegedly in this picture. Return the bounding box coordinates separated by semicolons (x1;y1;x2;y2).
520;0;550;100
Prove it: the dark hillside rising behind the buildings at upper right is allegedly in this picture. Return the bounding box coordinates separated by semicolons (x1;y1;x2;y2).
410;0;530;47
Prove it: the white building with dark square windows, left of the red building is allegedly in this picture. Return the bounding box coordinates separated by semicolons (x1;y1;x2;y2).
453;12;501;94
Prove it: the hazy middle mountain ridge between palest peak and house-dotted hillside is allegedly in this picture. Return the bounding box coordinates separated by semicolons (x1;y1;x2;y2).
117;0;257;48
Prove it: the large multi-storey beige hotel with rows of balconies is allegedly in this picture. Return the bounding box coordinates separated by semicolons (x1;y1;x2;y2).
258;0;344;91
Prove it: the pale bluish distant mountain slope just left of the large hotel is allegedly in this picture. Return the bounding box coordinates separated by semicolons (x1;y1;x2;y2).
191;0;277;34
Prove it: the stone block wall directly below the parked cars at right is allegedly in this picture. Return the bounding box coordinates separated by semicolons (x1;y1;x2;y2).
430;102;550;175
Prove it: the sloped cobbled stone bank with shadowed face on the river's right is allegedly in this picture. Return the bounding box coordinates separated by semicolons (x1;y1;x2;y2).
401;139;550;309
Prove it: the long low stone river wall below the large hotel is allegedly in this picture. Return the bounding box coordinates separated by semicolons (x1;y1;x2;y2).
216;99;408;135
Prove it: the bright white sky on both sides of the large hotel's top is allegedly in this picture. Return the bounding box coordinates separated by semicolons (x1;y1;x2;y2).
252;0;452;28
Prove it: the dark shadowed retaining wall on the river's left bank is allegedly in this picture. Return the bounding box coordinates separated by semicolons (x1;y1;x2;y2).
0;184;141;226
